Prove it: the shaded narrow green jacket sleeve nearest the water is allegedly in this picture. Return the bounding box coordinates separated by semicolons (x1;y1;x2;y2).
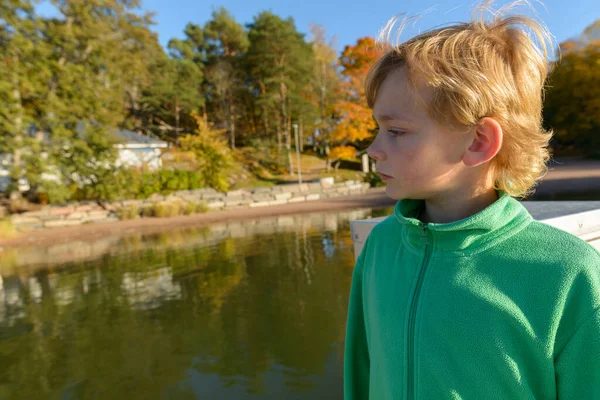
344;254;370;400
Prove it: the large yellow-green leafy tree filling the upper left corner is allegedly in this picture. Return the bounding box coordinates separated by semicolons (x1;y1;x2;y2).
0;0;169;201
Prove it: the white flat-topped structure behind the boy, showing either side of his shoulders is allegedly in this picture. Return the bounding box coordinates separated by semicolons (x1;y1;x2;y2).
350;201;600;258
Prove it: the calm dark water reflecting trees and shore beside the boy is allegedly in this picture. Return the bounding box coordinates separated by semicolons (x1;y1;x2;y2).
0;209;390;400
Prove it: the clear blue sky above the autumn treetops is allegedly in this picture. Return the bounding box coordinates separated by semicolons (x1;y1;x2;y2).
39;0;600;54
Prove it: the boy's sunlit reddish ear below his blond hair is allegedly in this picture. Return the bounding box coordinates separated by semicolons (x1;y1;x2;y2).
463;117;502;167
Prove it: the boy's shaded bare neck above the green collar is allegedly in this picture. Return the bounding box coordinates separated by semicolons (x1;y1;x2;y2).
418;187;498;224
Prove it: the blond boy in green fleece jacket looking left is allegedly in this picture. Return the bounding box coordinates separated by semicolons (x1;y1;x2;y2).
344;4;600;400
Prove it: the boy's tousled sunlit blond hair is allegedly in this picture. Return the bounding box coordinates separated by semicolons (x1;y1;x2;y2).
365;0;552;197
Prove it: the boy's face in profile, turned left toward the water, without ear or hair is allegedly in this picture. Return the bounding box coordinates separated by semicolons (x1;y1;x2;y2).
368;68;470;200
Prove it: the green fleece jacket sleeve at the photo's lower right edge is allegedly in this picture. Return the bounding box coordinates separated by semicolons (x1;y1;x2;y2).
554;308;600;400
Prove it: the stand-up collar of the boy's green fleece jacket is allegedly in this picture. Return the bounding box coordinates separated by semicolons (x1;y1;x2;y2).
394;191;533;254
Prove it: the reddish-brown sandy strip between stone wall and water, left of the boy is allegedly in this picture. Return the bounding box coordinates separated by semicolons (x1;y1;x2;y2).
0;188;395;252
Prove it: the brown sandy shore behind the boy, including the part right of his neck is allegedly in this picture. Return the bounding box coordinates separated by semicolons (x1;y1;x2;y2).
0;155;600;254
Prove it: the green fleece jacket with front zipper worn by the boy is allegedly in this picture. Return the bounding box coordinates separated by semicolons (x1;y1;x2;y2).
344;192;600;400
